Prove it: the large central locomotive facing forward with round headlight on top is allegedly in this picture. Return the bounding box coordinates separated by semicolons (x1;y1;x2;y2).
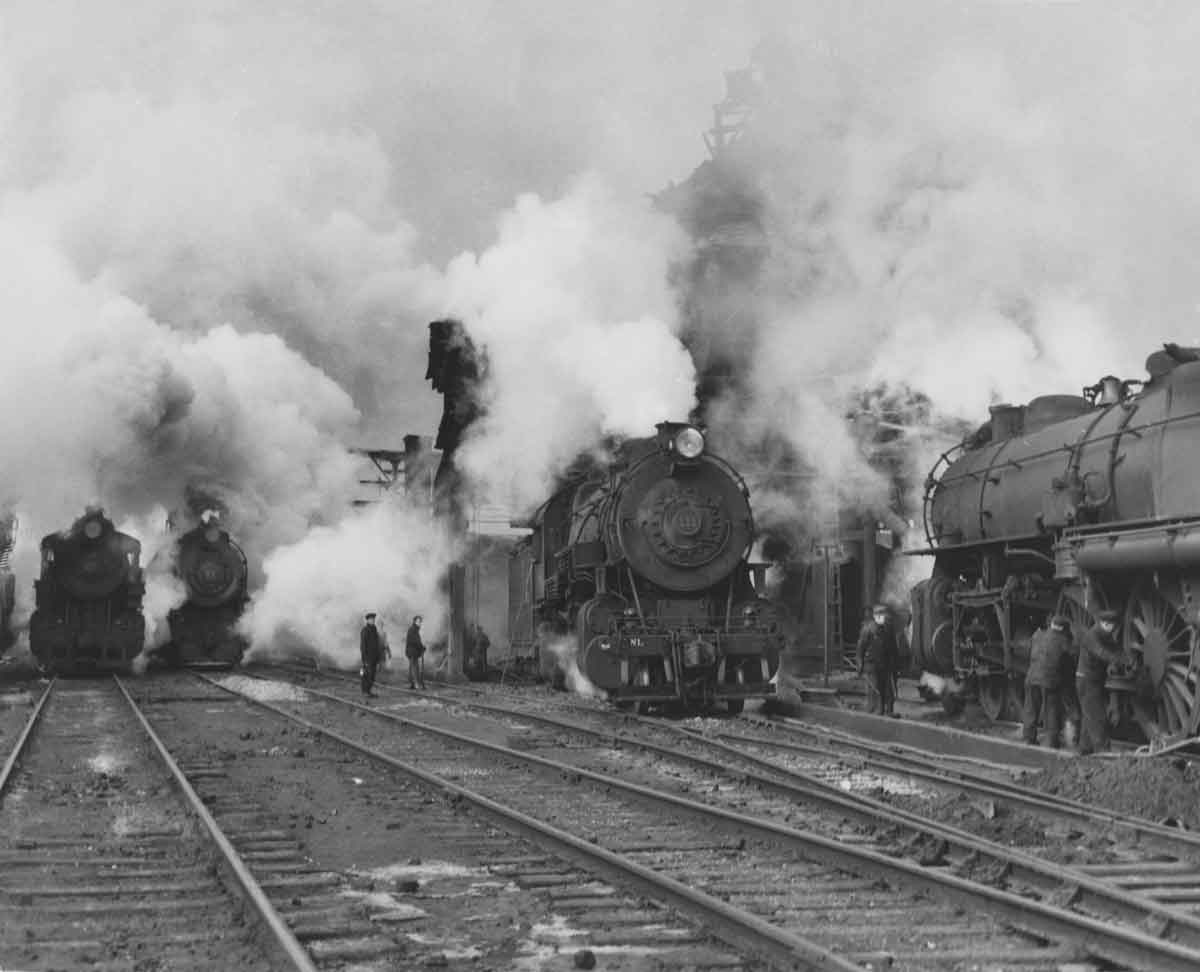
509;422;782;713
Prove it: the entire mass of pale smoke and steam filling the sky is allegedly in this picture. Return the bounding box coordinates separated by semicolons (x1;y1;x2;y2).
0;0;1200;654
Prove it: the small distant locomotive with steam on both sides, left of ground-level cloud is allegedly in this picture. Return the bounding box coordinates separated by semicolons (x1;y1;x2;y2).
160;520;247;667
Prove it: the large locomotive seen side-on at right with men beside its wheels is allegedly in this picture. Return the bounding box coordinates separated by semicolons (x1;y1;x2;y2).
912;344;1200;742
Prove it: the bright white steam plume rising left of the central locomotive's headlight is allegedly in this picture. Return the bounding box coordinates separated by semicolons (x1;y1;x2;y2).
446;179;695;510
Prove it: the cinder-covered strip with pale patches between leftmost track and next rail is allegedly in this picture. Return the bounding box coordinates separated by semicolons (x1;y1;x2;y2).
129;679;748;971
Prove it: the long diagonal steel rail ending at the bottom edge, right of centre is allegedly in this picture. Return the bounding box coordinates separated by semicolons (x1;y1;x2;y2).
206;674;862;972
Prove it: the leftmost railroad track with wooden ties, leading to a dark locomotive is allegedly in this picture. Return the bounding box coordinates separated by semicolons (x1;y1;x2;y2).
0;680;312;972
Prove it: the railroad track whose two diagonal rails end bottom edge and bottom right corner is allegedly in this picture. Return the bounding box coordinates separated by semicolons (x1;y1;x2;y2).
231;667;1200;970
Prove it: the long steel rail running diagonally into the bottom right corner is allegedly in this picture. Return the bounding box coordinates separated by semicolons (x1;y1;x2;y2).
234;683;1200;972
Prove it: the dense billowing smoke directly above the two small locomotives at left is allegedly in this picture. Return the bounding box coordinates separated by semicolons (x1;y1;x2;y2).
0;224;358;644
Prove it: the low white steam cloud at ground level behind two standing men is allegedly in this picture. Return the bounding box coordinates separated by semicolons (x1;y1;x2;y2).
241;497;455;667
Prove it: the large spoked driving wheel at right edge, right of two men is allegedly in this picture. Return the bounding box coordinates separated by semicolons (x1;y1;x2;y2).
1124;581;1200;736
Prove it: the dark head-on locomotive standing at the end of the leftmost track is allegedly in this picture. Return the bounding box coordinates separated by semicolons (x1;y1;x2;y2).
29;509;145;674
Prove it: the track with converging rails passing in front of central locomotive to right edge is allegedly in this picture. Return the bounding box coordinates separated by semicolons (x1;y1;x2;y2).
274;667;1200;948
